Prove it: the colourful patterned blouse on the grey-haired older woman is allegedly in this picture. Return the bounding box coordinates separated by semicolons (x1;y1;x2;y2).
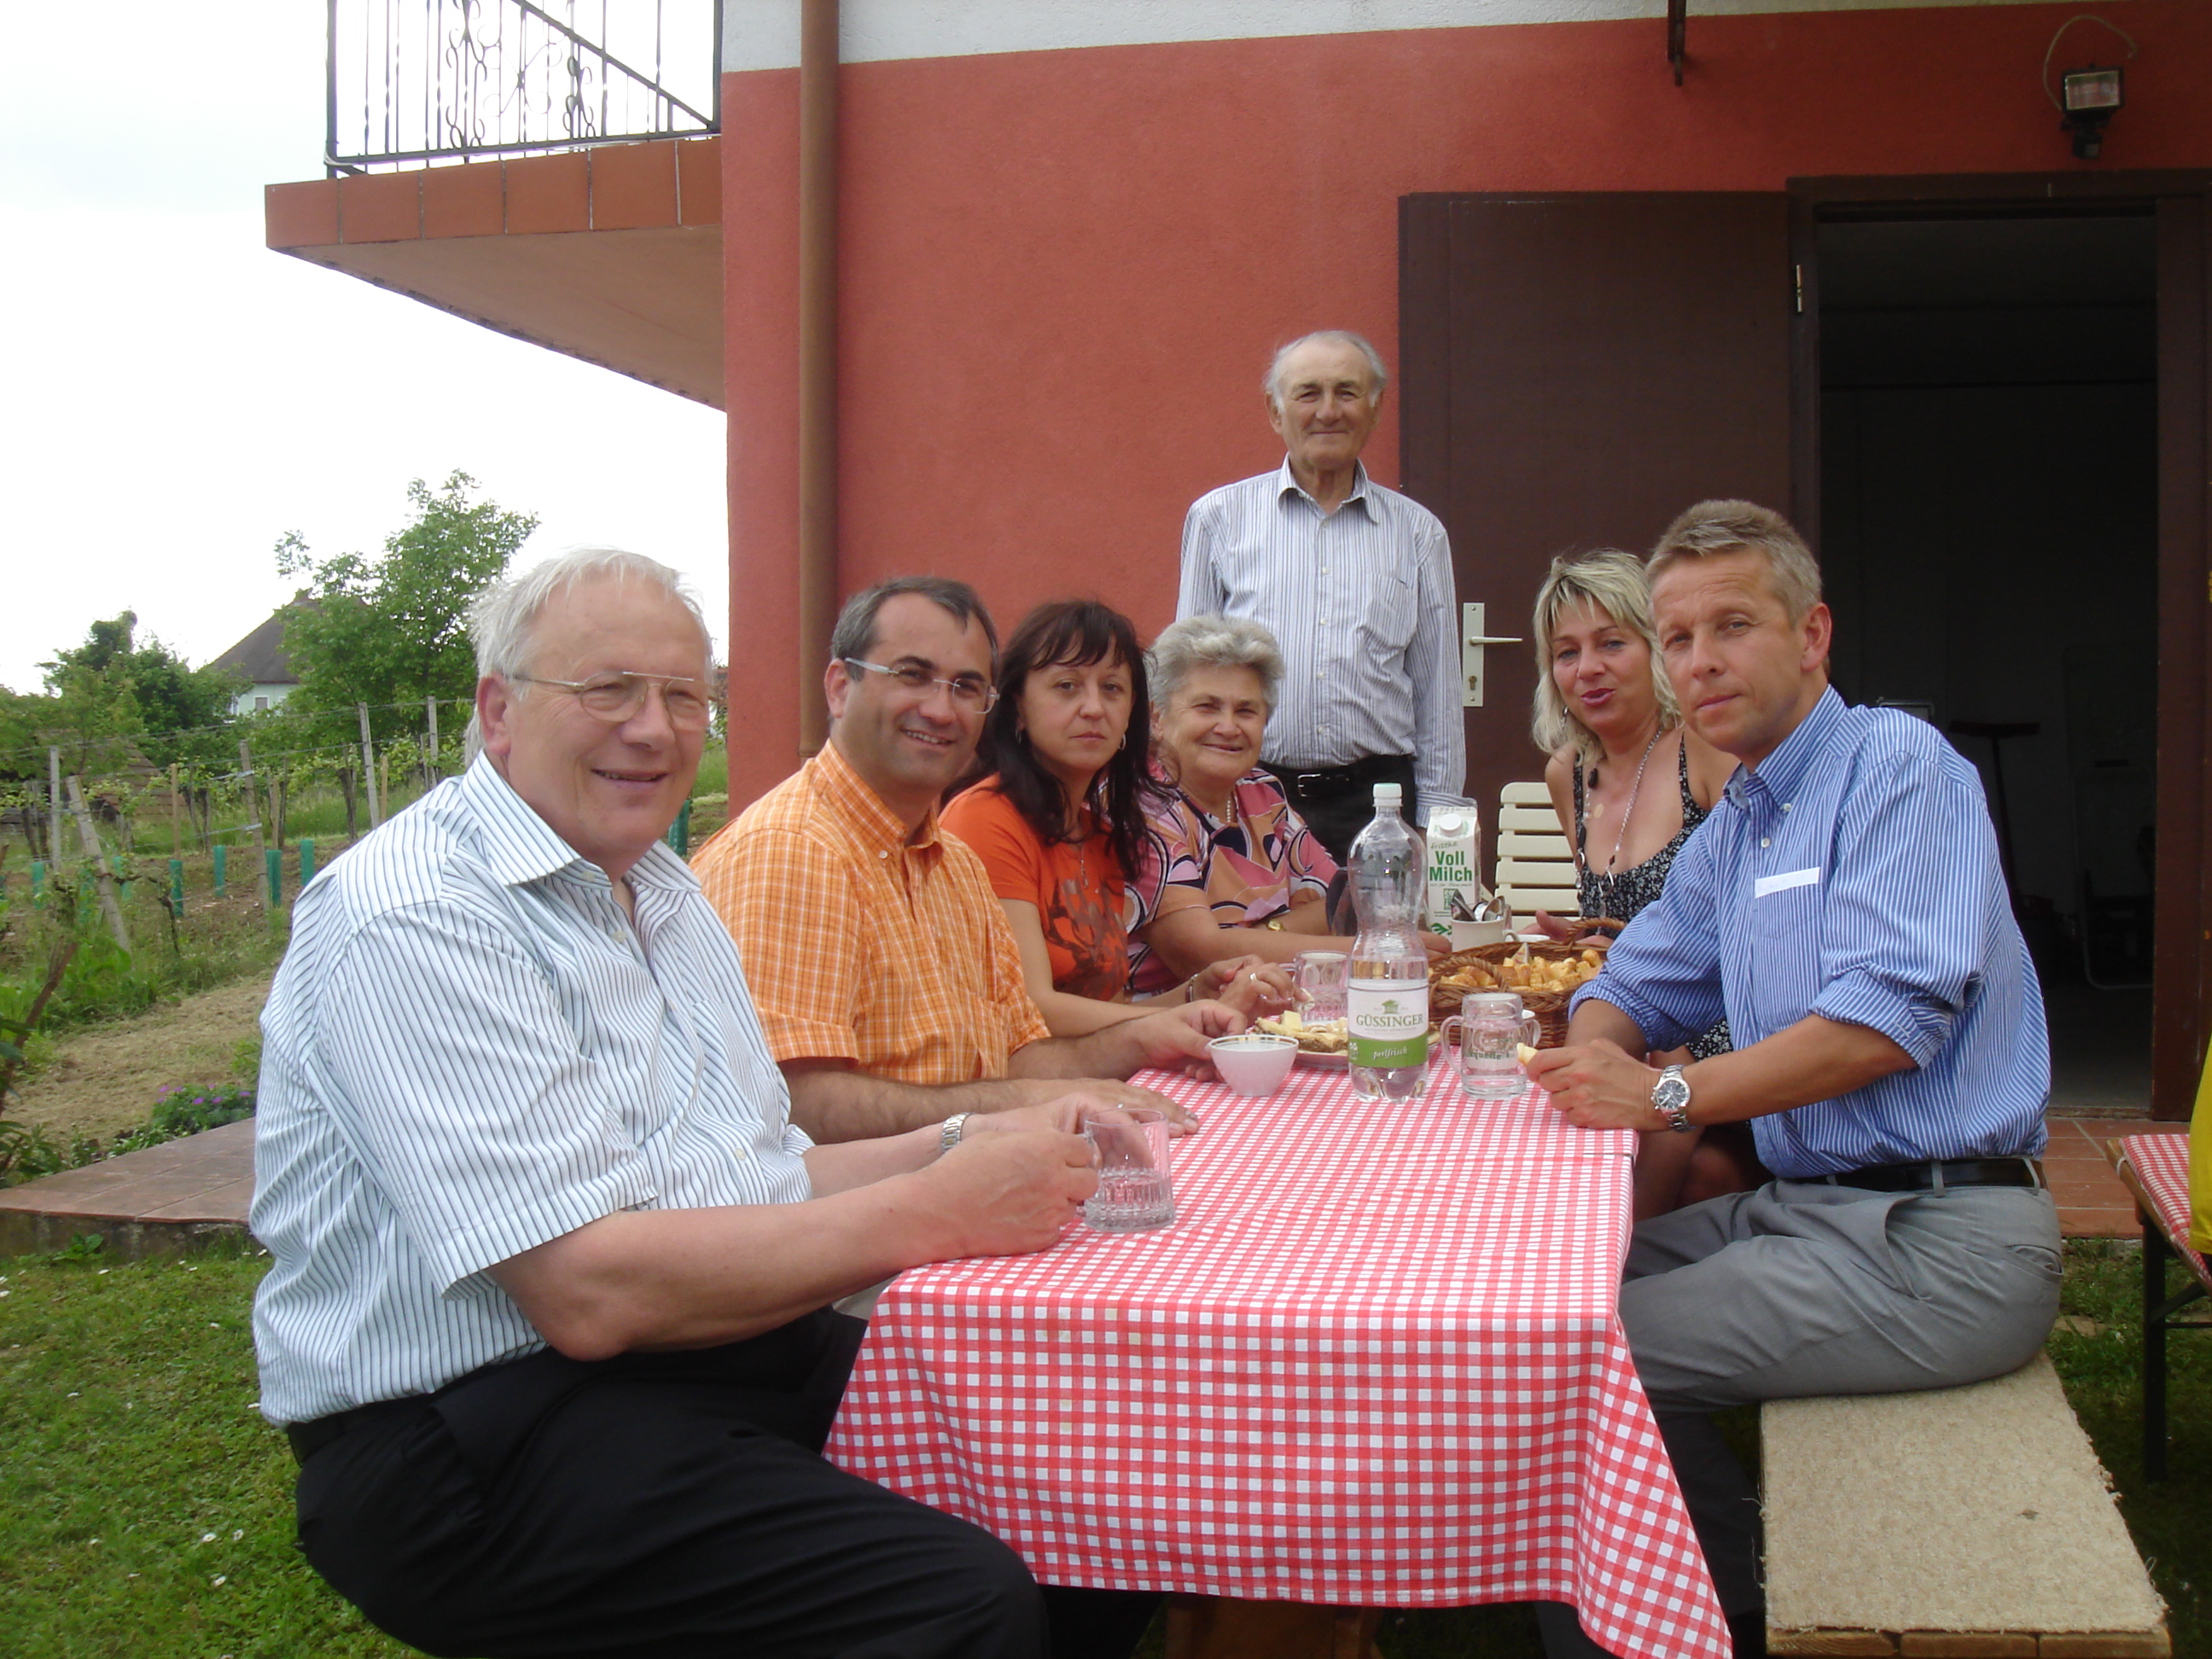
1128;770;1336;995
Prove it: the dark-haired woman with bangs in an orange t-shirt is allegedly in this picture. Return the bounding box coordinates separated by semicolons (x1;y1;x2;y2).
942;599;1289;1038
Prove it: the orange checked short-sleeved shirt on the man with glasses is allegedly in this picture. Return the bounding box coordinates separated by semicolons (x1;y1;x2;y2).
692;743;1051;1084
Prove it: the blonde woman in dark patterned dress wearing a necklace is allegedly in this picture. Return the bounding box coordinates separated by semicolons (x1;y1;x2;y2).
1531;549;1763;1219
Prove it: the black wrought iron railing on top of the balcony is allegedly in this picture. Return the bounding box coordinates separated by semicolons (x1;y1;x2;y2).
323;0;721;172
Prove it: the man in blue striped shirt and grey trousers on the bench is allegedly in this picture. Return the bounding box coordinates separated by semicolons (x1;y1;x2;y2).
1528;502;2059;1652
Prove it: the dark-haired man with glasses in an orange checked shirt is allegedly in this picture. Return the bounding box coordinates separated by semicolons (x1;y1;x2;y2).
692;578;1243;1144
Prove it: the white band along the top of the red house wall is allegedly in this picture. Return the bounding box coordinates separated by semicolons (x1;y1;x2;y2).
721;0;2037;73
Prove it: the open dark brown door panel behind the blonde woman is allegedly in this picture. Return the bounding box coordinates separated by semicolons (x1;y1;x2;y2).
1398;193;1796;823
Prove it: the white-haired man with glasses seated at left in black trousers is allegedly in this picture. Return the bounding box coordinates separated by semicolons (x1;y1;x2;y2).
252;550;1144;1659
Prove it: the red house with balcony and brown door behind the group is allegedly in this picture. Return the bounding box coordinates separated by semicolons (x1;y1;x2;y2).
268;0;2212;1113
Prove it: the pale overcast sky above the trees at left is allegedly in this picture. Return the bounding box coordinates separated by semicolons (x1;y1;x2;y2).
0;0;728;690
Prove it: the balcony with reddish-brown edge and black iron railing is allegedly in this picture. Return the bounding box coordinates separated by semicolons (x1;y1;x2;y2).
265;0;721;407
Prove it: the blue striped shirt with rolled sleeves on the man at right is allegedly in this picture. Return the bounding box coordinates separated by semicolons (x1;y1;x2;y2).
1575;690;2051;1177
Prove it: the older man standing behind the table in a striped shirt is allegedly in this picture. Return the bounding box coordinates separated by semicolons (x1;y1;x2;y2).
1174;329;1466;860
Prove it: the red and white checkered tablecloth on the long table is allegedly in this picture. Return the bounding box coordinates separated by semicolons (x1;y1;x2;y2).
830;1066;1727;1659
